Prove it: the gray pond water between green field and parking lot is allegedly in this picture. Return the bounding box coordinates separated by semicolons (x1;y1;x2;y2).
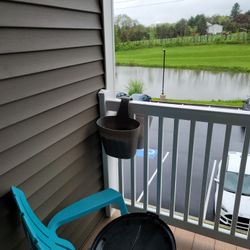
115;66;250;100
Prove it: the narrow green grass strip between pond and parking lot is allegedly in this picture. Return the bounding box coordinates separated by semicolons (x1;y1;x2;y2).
152;98;244;108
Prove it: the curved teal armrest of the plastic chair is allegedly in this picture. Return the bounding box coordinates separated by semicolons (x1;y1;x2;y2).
48;189;128;231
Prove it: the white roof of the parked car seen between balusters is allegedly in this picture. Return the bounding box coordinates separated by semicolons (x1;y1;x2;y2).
227;152;250;175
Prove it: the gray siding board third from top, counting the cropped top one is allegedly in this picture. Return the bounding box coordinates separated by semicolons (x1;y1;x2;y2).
0;28;102;54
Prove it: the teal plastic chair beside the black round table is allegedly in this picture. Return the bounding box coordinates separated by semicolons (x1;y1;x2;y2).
11;187;128;250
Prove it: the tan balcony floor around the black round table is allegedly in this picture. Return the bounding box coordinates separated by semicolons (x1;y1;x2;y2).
82;211;247;250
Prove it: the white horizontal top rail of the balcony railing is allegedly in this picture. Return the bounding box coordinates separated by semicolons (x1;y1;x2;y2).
106;98;250;126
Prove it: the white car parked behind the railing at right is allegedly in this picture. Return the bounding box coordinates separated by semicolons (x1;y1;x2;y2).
214;152;250;229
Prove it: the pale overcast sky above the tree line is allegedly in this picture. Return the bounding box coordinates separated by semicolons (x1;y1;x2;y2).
113;0;250;25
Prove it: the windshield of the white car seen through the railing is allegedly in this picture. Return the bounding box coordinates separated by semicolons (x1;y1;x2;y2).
224;171;250;196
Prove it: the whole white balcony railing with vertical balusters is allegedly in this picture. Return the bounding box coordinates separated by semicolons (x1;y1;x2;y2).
99;91;250;248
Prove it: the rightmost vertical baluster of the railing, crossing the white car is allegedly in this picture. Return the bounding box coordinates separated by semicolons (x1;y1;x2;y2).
231;127;250;235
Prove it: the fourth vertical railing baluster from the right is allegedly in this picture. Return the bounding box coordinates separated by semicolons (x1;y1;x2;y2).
184;120;195;221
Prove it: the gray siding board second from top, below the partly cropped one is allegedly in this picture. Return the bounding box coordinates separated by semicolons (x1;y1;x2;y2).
0;2;101;29
